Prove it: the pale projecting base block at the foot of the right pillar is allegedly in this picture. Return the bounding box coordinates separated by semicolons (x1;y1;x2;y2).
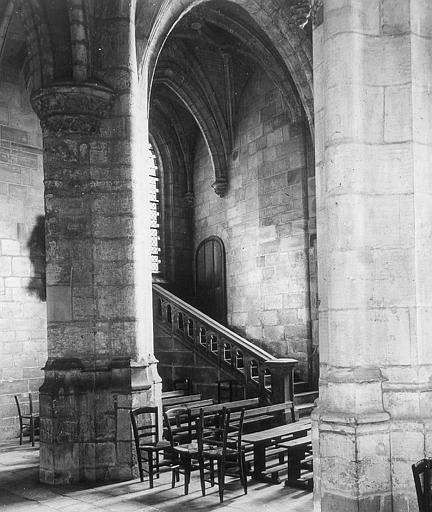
312;405;392;512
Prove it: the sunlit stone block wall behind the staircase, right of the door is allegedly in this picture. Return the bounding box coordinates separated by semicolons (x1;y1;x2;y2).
194;68;315;378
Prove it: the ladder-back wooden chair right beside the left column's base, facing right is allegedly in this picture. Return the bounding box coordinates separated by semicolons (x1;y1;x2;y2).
130;407;171;489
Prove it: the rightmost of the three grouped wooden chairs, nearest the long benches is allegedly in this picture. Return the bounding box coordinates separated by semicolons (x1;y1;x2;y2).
197;408;247;503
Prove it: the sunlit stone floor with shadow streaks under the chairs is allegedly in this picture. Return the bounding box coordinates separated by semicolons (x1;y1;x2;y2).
0;441;313;512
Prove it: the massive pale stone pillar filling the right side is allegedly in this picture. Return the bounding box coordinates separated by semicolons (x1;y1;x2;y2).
313;0;432;512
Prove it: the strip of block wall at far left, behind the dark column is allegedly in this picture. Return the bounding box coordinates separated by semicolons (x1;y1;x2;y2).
0;69;46;439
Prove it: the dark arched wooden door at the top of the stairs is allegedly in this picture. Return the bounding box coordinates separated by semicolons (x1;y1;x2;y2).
195;236;226;324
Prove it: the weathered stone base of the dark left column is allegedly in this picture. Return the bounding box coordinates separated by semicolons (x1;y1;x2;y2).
39;358;162;485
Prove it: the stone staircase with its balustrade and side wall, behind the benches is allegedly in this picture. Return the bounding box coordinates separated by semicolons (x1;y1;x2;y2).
153;284;318;419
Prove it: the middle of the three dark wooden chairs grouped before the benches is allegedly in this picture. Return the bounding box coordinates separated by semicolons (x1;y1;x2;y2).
164;406;205;495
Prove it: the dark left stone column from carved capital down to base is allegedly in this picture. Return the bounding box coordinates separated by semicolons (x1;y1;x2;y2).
32;84;161;484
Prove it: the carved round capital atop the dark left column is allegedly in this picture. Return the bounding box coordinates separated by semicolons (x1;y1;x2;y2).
31;83;114;135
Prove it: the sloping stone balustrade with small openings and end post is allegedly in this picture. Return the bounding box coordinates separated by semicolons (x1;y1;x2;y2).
153;284;297;403
